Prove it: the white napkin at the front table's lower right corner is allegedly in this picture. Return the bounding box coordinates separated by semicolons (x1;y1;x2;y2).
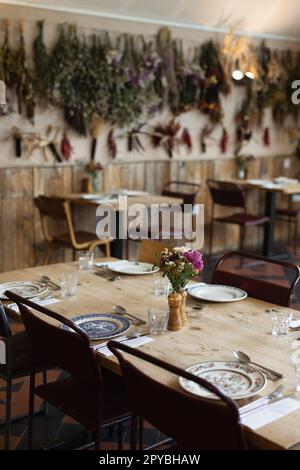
241;398;300;429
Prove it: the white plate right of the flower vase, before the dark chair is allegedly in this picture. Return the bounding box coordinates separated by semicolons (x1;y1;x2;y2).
188;284;247;302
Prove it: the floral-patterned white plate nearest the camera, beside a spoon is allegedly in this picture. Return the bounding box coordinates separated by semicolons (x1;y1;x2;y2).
179;361;267;400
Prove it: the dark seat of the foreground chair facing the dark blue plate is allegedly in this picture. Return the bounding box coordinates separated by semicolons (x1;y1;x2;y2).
35;369;130;431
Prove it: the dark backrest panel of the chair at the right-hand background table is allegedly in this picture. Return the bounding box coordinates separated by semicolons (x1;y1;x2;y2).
206;179;246;208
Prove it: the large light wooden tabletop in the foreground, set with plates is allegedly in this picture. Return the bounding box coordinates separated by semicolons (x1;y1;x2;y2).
0;263;300;449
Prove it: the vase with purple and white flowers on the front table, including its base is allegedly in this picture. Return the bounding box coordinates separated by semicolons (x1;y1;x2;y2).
159;246;204;331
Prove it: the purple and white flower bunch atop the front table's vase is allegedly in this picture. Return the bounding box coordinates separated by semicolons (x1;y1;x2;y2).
159;246;204;292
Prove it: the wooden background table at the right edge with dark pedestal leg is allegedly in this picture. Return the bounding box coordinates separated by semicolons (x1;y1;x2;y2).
224;180;300;257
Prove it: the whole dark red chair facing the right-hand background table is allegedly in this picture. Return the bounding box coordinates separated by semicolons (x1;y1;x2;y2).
207;179;270;255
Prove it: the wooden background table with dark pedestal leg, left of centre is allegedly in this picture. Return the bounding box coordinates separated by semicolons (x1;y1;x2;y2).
59;190;183;259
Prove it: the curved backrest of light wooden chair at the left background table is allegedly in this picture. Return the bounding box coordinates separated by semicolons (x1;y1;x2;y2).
34;196;76;245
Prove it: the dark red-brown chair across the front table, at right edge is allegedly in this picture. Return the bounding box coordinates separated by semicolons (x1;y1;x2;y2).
211;251;300;307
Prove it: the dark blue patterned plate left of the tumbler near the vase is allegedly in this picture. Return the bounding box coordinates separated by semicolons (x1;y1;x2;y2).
63;313;131;340
